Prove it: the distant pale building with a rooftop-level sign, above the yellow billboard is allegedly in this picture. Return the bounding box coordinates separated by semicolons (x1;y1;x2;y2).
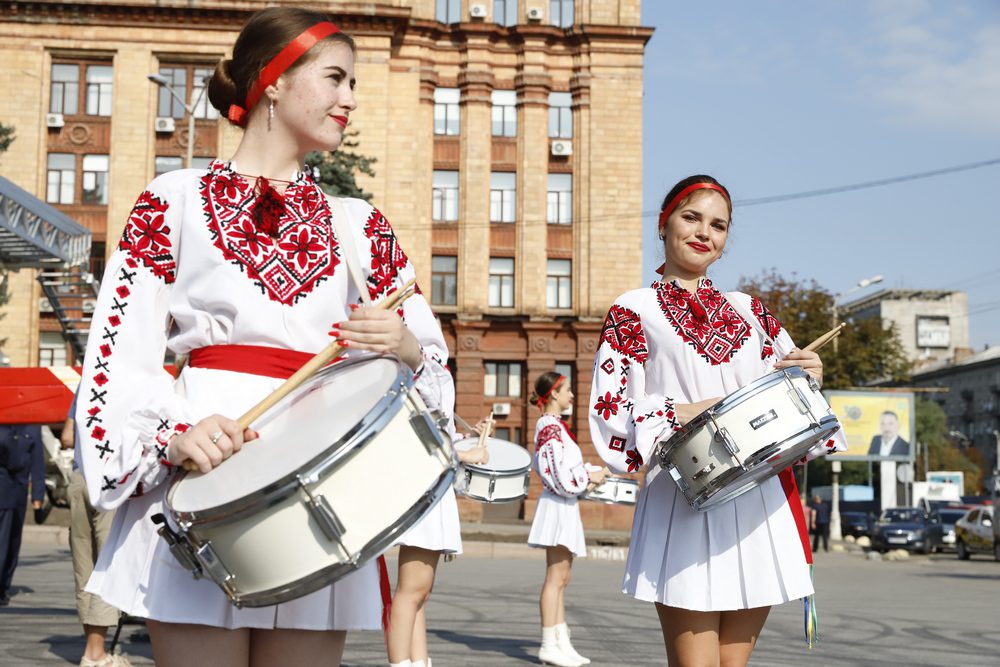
840;289;969;368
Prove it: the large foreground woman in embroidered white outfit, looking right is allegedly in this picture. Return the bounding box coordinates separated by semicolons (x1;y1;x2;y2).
76;7;454;666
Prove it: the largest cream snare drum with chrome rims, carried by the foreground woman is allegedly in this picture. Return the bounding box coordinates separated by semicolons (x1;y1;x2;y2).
159;356;457;607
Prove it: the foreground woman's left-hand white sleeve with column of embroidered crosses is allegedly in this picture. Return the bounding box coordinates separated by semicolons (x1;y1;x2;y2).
75;174;190;510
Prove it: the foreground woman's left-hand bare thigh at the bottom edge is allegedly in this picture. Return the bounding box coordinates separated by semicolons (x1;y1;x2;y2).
146;620;250;667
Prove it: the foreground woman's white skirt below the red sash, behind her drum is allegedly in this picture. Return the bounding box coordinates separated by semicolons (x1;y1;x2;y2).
86;368;382;630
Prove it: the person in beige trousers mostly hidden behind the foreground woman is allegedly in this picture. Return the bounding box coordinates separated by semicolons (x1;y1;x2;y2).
59;408;131;667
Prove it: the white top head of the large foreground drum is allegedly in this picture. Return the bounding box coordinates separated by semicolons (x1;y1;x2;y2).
167;357;400;512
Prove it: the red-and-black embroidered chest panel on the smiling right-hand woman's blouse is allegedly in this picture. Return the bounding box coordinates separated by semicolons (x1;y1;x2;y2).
653;278;750;366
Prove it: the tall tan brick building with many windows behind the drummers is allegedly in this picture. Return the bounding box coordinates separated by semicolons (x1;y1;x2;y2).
0;0;652;527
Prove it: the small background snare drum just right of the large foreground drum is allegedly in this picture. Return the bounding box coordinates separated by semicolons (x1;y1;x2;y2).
455;437;531;503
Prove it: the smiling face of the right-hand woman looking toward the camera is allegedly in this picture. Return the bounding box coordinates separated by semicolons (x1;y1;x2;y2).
663;190;729;275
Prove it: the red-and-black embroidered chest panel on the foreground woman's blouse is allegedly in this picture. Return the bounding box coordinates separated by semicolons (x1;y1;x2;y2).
201;162;340;305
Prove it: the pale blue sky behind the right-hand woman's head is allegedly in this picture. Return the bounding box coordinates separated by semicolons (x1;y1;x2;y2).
642;0;1000;350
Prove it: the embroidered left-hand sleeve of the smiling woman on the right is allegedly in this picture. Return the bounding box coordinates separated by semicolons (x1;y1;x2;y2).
590;295;680;473
